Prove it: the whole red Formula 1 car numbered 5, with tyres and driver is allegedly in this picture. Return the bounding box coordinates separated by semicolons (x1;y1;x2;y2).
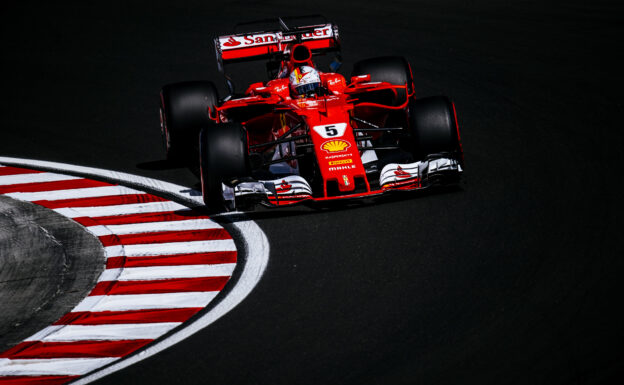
160;17;463;210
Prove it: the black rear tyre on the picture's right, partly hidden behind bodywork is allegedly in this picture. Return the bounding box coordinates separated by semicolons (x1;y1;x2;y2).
351;56;414;105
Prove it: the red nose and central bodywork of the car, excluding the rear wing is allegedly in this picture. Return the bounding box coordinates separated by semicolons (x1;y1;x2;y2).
211;68;412;203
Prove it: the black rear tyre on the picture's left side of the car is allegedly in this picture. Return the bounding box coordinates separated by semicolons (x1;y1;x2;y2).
160;81;219;163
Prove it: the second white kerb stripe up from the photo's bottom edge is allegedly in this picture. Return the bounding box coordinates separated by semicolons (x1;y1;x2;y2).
26;322;181;342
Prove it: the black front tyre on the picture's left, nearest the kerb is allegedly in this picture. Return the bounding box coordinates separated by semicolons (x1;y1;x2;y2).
199;123;249;211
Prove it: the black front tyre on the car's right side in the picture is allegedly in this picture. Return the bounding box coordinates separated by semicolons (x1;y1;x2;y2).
408;96;463;166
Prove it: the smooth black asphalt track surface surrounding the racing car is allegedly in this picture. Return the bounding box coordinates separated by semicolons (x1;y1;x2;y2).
0;0;624;384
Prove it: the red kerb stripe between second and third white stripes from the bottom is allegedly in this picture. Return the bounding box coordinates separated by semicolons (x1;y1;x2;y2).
54;307;202;325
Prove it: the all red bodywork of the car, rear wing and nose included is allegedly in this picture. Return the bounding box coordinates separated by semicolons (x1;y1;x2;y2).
209;19;428;206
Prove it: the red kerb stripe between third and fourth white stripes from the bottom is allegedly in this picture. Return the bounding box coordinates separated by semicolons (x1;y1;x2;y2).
89;276;230;296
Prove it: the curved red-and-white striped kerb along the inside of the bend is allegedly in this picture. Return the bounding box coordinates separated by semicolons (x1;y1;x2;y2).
0;165;237;384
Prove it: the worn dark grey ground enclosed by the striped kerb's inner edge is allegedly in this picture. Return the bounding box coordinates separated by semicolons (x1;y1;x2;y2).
0;196;104;352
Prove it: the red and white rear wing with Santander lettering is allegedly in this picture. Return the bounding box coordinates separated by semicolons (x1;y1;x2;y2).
214;18;340;72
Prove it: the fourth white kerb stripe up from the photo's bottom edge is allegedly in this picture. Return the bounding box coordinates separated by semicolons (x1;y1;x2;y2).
98;263;236;282
